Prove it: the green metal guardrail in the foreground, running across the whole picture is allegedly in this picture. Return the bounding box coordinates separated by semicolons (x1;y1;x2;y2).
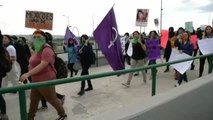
0;54;213;120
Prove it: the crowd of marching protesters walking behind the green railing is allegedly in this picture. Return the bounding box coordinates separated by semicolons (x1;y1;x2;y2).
0;26;213;120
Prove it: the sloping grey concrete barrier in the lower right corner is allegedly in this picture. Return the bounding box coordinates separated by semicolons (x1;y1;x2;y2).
91;74;213;120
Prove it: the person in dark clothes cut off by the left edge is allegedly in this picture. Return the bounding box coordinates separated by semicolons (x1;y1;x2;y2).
0;31;12;120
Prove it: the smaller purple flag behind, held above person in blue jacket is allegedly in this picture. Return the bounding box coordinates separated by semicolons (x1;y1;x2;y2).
64;27;80;46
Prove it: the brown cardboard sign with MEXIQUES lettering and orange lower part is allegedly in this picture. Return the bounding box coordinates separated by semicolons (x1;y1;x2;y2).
25;11;53;30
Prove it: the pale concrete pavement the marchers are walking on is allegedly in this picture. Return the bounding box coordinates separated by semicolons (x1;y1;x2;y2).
4;60;207;120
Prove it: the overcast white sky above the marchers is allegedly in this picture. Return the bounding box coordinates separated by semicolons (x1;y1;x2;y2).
0;0;213;35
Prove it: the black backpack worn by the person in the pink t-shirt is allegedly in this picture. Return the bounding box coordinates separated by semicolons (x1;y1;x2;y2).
43;45;68;79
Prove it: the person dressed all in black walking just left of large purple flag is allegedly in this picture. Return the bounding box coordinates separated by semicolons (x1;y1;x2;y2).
78;34;94;96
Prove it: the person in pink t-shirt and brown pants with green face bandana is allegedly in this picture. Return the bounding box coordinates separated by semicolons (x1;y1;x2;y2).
20;30;67;120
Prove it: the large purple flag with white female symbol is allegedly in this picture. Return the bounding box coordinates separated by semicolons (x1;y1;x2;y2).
94;7;124;70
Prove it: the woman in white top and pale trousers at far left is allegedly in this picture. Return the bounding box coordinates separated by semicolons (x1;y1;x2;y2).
2;35;21;87
